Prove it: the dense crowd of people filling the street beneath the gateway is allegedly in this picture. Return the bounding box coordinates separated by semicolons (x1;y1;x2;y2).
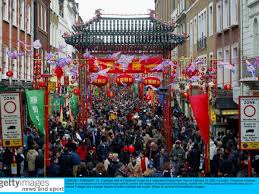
0;90;259;177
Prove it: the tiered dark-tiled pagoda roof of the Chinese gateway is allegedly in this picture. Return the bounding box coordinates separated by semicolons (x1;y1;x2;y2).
64;12;187;53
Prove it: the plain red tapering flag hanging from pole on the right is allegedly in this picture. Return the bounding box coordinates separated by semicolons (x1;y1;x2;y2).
190;94;210;144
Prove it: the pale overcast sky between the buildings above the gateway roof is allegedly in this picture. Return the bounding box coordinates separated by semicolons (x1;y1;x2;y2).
76;0;155;21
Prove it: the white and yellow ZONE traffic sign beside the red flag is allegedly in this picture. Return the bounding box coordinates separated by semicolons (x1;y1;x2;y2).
239;96;259;150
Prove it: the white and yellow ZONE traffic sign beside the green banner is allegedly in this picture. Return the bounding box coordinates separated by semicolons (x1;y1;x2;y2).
0;92;23;147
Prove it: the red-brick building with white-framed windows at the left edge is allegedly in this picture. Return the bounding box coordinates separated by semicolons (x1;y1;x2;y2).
0;0;34;86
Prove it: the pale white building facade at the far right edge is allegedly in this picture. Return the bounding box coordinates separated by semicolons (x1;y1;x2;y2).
240;0;259;96
